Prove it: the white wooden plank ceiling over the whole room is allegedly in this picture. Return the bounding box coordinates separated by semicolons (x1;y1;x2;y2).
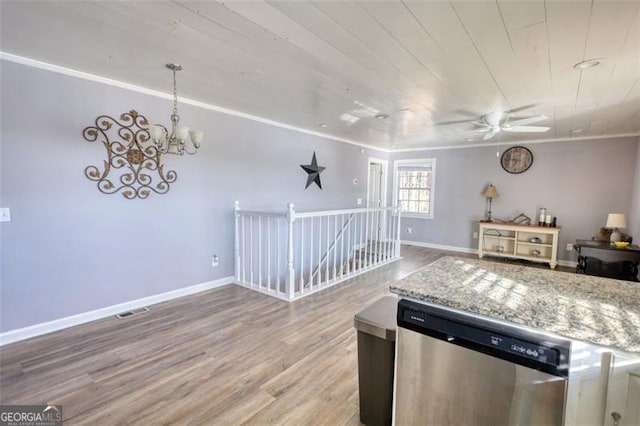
0;0;640;150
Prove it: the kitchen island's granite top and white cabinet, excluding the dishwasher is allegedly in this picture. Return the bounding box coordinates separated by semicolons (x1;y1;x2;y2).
390;257;640;425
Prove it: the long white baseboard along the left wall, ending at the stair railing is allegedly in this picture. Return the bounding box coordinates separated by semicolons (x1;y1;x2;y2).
0;276;235;346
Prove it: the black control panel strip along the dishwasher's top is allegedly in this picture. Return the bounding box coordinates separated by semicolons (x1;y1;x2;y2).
398;300;571;376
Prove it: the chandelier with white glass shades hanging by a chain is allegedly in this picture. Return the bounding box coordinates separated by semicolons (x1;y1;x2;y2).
149;64;204;155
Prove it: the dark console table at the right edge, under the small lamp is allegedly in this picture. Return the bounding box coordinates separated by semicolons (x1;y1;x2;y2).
574;240;640;281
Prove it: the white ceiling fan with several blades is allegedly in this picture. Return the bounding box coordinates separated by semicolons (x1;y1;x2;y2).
436;105;550;141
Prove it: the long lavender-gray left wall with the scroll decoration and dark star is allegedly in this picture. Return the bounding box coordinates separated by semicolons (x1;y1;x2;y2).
0;61;386;331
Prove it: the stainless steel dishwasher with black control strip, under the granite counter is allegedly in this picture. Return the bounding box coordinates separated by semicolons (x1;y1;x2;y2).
393;299;571;426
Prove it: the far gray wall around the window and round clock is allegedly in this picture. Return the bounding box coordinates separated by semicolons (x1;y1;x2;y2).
389;137;640;261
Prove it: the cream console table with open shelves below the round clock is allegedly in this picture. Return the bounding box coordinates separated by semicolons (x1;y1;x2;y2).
478;222;560;269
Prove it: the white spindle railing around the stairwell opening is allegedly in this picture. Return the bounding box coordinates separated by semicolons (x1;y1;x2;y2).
234;202;400;300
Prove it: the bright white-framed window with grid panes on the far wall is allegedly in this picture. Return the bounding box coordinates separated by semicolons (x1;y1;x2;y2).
393;158;436;219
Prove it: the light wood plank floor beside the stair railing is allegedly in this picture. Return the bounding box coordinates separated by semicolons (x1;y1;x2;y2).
0;246;568;425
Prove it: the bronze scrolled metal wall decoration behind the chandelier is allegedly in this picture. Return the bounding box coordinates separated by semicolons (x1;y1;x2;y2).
82;110;178;200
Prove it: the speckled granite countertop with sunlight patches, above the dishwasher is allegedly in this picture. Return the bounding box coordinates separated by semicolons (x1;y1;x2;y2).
390;257;640;355
